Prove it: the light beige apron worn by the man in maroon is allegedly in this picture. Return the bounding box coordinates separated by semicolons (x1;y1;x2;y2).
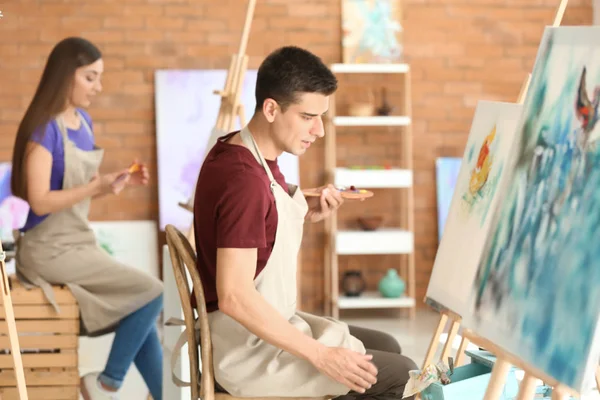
169;128;365;397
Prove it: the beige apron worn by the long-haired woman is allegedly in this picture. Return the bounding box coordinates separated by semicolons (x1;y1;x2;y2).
15;115;163;336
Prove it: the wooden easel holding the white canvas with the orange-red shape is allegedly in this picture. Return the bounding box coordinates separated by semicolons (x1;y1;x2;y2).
423;0;564;376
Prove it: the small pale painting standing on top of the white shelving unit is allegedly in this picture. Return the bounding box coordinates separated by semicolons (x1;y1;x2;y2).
341;0;403;64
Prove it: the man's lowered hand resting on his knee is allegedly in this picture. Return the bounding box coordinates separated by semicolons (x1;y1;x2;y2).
313;347;377;393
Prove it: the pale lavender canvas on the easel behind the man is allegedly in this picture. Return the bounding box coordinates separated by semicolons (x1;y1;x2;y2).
155;70;299;232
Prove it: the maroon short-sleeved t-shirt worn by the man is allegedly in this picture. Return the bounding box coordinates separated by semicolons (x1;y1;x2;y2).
192;132;287;312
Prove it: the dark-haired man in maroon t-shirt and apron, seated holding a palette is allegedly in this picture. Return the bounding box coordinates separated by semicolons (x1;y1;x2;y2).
194;46;417;399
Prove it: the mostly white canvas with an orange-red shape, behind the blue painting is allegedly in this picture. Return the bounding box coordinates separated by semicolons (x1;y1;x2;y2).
426;101;523;315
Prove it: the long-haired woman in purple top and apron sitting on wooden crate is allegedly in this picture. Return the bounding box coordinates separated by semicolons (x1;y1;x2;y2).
11;38;163;400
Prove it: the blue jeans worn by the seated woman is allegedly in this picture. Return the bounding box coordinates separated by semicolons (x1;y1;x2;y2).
98;294;163;400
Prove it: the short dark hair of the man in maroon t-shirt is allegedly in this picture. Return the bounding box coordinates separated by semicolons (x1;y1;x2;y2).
255;46;337;111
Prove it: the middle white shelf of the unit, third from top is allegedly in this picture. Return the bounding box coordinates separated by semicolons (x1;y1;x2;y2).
335;168;413;189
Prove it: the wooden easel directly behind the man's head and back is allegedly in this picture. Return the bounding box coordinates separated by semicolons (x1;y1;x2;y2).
179;0;256;249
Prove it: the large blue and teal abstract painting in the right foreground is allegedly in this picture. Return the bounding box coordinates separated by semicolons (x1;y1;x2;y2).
463;27;600;393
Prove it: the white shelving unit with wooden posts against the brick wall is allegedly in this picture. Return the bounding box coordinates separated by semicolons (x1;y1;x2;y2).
325;64;416;318
